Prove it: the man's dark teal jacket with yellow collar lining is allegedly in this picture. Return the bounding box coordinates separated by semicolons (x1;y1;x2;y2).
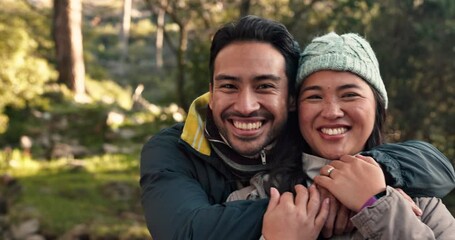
140;95;455;240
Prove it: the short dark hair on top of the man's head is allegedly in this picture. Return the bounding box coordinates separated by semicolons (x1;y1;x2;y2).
209;15;300;96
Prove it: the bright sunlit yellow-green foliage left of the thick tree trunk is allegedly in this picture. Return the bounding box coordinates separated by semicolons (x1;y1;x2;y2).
0;1;56;133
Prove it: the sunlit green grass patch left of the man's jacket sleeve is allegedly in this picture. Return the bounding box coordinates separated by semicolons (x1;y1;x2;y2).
4;152;151;239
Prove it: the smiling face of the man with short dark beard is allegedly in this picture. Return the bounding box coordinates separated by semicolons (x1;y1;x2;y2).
209;42;289;156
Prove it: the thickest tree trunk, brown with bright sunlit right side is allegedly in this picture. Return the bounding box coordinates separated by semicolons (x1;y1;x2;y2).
53;0;86;101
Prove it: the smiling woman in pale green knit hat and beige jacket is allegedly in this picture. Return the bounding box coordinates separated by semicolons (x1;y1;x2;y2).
232;33;455;240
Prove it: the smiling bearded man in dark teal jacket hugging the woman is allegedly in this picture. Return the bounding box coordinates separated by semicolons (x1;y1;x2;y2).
140;16;454;240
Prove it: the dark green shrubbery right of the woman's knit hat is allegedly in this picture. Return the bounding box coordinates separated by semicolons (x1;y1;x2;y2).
369;1;455;159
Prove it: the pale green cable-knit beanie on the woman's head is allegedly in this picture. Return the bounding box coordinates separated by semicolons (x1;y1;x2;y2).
296;32;388;109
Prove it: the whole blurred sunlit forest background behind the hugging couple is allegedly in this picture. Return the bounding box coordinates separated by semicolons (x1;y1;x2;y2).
0;0;455;239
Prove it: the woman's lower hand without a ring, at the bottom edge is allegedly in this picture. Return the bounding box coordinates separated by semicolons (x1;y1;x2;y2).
262;184;329;240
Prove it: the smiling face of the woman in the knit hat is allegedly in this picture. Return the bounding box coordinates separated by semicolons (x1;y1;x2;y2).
298;71;376;160
